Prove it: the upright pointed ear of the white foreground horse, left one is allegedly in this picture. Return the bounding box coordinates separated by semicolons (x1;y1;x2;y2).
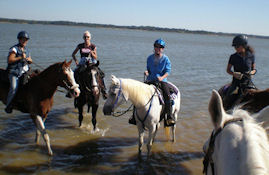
208;90;225;129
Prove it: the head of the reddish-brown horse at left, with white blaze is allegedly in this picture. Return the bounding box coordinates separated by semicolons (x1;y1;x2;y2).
59;60;80;97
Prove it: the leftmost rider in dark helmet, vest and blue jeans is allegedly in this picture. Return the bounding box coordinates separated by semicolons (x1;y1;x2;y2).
5;31;32;113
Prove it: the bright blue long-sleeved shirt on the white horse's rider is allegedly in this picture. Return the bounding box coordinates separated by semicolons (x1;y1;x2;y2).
147;54;171;82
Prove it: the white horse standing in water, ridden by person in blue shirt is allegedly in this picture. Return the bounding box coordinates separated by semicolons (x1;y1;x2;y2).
103;75;180;157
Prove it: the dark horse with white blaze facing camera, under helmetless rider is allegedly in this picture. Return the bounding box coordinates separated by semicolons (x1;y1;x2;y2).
74;63;101;130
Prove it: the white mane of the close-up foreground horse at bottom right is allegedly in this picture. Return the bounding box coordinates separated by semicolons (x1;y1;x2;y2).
228;109;269;174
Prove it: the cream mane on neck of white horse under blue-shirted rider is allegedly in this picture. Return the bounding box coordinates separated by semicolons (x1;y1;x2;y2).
121;79;154;103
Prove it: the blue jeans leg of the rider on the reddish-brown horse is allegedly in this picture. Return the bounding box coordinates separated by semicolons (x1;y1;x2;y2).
6;74;19;107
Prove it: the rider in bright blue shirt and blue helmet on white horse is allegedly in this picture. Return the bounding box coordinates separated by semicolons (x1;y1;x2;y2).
129;39;175;126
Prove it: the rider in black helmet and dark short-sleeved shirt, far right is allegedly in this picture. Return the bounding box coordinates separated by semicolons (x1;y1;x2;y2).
224;35;256;110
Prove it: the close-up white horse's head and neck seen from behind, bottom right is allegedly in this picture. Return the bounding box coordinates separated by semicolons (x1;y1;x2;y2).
203;90;269;175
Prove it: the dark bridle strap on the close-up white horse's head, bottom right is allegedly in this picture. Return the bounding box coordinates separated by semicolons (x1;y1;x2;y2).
203;118;243;175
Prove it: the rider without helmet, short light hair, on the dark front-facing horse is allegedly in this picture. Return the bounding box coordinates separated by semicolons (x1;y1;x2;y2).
68;31;107;99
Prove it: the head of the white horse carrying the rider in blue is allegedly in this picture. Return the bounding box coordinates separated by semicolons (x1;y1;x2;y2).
103;75;128;115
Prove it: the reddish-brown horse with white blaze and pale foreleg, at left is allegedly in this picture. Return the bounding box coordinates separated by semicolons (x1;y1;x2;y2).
0;60;80;156
